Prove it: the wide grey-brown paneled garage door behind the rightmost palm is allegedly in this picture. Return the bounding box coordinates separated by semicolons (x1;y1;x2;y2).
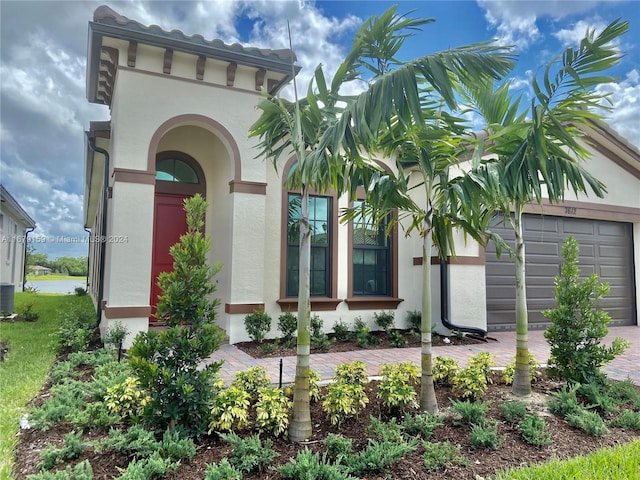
486;215;635;331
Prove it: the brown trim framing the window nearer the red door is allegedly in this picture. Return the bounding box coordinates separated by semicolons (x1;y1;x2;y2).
276;157;342;312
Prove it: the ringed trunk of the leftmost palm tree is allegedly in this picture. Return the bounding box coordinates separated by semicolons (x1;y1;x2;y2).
289;186;312;442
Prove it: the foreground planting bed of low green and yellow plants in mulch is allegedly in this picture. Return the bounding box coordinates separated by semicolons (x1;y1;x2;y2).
11;349;640;480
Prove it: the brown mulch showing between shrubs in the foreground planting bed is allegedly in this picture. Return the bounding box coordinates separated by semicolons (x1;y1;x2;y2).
15;372;640;480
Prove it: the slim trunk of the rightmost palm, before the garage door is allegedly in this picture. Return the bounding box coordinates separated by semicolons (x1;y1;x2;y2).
511;205;531;396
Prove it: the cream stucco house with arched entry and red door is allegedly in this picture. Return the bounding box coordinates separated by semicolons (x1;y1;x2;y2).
85;6;640;343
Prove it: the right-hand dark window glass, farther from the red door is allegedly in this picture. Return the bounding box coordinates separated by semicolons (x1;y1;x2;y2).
351;201;391;296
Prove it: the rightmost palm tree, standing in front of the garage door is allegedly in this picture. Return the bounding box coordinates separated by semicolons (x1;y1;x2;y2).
468;19;629;396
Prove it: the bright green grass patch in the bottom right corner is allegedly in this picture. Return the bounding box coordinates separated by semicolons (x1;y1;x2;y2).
493;440;640;480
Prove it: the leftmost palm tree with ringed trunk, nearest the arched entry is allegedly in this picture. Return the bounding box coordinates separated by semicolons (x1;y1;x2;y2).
249;7;440;442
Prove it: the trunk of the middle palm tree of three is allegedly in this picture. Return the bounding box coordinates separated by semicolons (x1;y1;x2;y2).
420;214;438;413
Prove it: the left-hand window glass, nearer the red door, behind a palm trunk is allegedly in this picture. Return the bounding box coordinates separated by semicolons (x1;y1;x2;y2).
285;193;332;297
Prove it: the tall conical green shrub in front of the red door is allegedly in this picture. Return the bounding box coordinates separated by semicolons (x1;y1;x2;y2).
129;194;224;436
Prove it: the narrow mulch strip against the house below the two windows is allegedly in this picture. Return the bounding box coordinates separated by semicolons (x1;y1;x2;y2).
234;330;484;358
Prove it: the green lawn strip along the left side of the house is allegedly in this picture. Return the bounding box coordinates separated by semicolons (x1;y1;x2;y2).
0;293;93;479
